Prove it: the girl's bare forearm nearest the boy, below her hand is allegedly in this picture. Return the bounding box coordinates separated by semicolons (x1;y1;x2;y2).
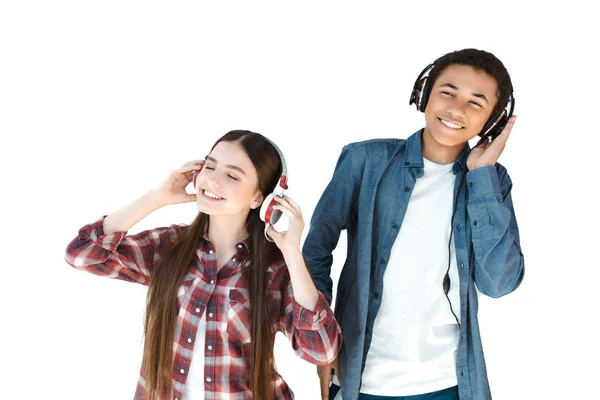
283;249;319;311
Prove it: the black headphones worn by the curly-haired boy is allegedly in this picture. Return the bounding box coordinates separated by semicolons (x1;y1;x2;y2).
408;63;515;140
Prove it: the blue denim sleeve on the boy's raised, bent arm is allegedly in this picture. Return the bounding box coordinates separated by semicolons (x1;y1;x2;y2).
466;165;524;297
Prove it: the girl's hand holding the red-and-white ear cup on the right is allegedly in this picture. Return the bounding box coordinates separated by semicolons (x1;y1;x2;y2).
267;196;304;255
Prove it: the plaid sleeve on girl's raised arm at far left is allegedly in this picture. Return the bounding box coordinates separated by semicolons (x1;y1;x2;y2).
65;217;183;285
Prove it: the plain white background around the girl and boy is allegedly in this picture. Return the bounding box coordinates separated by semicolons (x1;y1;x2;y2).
0;0;600;400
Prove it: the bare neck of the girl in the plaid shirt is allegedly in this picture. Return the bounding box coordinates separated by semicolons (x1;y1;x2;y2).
208;213;248;252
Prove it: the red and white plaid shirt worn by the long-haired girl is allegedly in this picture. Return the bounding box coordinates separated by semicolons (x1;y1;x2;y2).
65;218;342;400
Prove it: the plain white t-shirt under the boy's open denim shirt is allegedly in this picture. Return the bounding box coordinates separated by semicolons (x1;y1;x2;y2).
356;159;460;396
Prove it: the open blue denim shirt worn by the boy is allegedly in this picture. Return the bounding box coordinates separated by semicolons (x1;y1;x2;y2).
302;130;524;400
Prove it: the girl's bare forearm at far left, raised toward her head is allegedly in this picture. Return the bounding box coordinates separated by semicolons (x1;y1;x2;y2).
104;190;164;234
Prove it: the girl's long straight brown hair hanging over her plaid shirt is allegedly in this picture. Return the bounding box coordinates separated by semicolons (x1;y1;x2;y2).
142;130;282;400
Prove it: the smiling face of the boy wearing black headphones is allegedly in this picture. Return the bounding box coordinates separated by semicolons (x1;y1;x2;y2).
425;65;498;147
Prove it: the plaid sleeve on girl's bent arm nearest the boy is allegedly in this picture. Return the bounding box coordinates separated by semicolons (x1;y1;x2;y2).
274;267;342;365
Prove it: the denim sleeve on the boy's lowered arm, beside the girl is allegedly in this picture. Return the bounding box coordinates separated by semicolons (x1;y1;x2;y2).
302;145;359;304
